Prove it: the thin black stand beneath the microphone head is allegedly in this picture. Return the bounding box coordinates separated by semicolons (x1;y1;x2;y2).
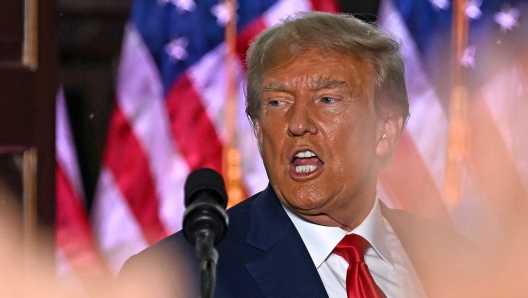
194;229;218;298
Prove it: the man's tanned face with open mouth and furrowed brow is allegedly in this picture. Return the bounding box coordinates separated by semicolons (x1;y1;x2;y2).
256;51;384;228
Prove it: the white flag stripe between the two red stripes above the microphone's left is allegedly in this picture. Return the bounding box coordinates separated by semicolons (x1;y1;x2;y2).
117;24;189;232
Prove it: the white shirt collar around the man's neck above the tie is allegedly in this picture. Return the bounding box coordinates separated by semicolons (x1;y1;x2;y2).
282;199;394;268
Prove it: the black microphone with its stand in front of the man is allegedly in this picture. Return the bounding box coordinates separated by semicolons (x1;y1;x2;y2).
183;168;228;297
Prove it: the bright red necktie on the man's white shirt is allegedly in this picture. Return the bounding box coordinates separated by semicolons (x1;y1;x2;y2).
333;234;386;298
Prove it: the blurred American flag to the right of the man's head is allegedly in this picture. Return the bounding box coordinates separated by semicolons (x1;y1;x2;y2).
378;0;528;241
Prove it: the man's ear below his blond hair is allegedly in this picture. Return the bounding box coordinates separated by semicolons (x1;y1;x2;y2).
376;115;403;168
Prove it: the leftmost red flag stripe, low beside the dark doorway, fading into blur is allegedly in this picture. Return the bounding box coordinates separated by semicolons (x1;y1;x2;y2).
55;164;108;277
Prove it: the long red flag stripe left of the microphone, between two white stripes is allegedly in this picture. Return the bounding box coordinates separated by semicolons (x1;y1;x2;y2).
104;106;168;244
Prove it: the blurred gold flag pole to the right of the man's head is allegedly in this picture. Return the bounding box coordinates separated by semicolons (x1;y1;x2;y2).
444;0;469;206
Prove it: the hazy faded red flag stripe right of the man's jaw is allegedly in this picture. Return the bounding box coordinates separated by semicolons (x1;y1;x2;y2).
379;131;453;225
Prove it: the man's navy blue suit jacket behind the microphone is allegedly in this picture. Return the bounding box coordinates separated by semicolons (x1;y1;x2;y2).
120;186;478;298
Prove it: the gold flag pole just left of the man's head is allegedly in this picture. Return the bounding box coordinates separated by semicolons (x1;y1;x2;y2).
222;0;244;208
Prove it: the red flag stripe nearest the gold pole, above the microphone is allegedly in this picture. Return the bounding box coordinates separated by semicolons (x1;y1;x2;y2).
167;70;223;173
